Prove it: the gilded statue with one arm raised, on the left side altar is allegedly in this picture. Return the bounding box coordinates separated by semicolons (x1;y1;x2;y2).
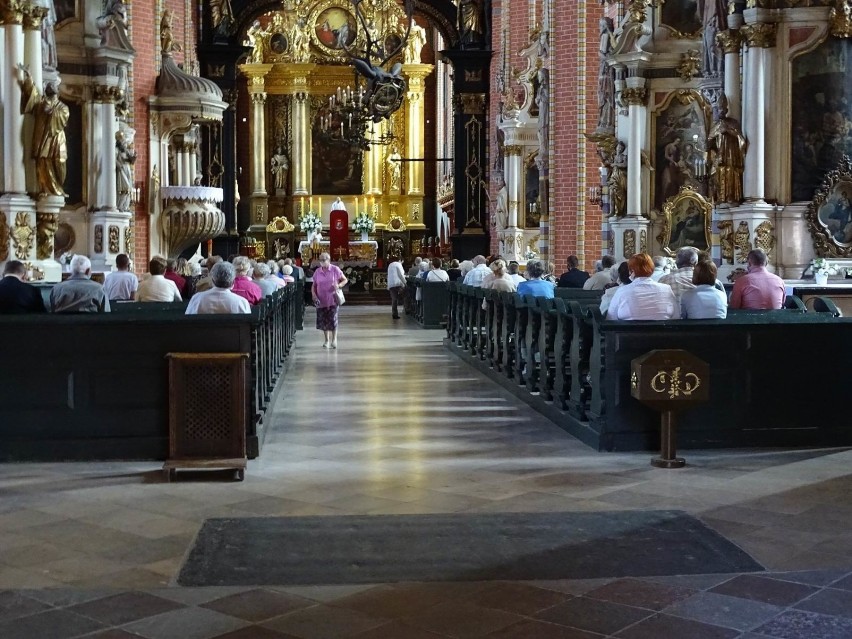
18;64;70;196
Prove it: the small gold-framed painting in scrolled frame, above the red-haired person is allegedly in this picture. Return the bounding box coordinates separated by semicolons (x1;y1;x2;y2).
657;186;713;255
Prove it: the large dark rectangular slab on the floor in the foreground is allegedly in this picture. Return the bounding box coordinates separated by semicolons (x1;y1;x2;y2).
178;511;762;586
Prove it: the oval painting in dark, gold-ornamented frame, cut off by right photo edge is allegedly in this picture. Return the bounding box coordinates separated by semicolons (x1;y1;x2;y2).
805;156;852;257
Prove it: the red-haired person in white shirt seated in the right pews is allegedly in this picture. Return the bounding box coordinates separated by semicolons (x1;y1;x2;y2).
607;253;680;320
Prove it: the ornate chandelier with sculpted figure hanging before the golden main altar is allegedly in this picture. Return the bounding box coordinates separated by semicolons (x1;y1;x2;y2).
318;0;414;150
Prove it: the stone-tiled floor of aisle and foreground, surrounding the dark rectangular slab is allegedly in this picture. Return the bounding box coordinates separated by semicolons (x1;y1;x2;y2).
0;307;852;639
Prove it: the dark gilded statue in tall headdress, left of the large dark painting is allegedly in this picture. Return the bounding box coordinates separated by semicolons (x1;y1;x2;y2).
707;93;748;204
